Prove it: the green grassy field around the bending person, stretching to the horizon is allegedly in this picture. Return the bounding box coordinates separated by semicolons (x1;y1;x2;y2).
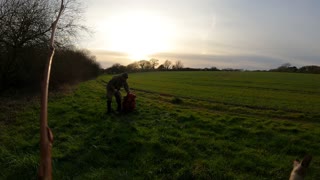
0;72;320;180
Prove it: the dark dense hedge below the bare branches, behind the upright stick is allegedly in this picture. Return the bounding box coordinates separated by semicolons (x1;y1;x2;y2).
0;47;101;91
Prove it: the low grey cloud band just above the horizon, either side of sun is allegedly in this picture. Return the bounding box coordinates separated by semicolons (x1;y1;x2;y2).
91;50;320;70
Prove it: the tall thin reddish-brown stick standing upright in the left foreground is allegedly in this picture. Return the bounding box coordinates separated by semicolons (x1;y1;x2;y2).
38;0;64;180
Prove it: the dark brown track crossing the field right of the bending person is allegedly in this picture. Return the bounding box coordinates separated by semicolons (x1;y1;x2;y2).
131;88;319;123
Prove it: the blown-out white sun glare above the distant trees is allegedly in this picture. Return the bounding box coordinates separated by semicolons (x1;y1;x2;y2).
105;13;174;60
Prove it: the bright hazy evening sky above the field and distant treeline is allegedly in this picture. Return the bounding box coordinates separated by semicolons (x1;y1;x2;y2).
79;0;320;70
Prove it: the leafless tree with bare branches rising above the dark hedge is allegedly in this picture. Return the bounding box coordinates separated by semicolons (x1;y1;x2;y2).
0;0;86;88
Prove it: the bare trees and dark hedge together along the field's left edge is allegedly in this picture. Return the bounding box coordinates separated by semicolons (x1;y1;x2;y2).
0;0;101;91
